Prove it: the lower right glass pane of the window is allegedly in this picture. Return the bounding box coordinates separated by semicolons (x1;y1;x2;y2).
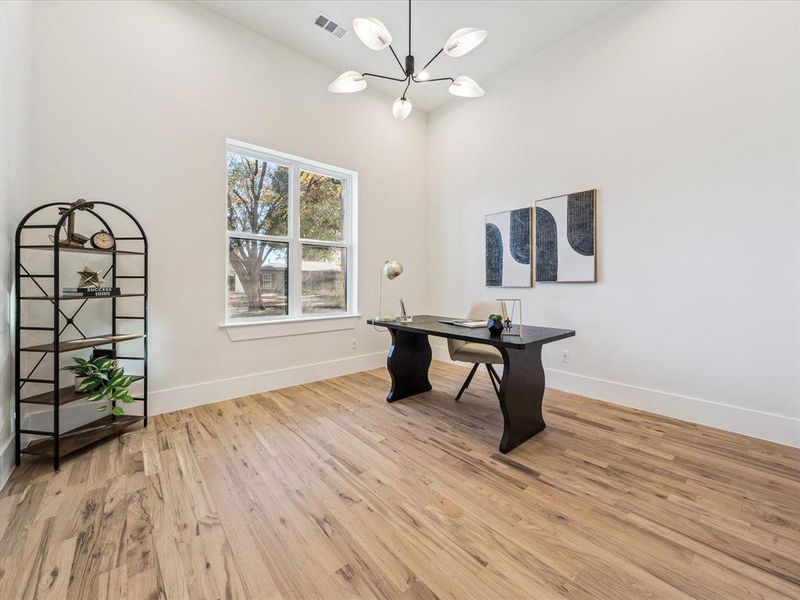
303;244;347;313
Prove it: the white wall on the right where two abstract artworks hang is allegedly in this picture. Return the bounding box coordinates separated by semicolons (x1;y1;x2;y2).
428;2;800;445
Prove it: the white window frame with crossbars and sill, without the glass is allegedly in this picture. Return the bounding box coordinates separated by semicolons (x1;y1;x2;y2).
223;139;359;332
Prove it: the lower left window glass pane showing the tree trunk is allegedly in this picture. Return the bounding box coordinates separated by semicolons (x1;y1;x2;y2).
228;237;289;319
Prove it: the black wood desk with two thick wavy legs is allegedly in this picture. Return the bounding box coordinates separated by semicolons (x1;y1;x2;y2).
367;315;575;453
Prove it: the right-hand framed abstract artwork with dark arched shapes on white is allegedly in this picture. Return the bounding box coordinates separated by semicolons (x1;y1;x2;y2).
536;190;597;283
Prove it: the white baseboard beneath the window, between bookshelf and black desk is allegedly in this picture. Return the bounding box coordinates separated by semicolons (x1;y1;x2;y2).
149;352;386;415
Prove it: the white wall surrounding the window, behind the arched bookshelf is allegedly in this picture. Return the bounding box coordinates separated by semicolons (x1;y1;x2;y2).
21;2;427;412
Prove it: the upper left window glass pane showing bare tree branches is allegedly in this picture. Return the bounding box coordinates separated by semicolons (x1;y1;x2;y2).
228;152;289;235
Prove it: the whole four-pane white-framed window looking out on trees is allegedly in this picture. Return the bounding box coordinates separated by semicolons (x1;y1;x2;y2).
226;140;357;323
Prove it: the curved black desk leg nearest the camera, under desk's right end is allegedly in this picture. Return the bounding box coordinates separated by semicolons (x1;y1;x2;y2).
499;344;545;454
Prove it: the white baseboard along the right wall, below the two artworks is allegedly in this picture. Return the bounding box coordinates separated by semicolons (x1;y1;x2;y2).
433;346;800;448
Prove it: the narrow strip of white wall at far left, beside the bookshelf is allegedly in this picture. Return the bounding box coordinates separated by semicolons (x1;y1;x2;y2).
0;2;33;487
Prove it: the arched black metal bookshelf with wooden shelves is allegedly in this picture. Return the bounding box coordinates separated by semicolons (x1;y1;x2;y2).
14;201;148;470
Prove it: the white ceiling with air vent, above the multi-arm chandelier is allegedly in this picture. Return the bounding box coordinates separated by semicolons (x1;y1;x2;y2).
196;0;625;112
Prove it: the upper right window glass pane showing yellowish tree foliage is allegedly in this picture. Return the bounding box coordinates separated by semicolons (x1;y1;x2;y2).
300;171;344;242
